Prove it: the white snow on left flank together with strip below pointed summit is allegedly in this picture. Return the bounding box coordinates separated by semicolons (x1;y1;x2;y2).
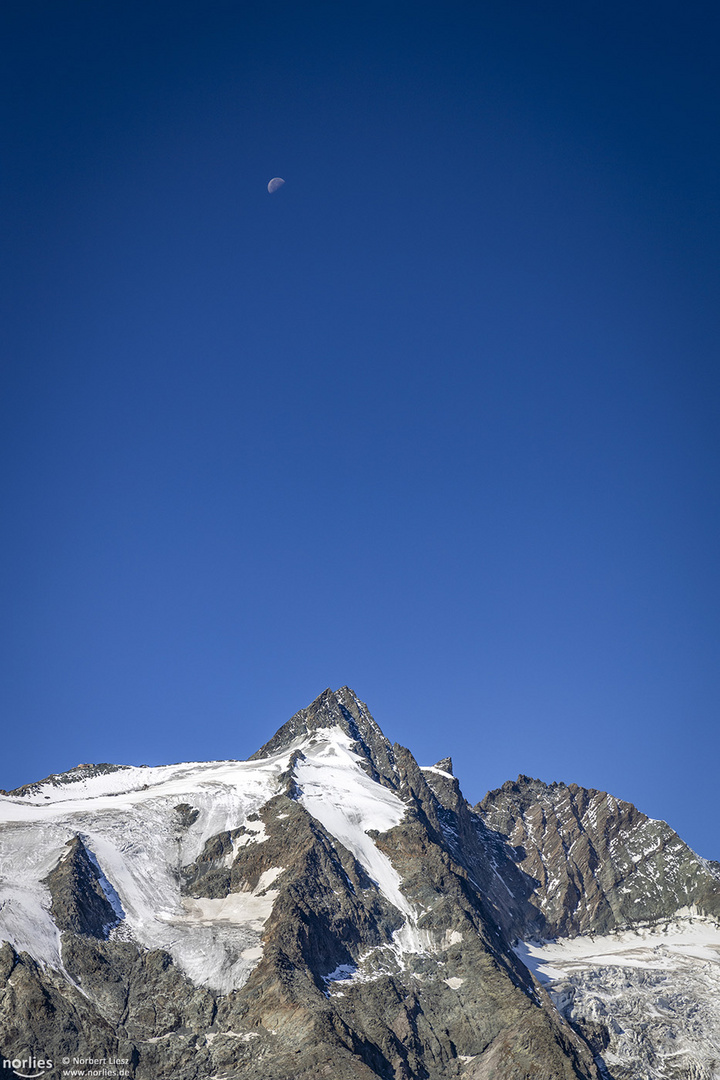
0;728;423;991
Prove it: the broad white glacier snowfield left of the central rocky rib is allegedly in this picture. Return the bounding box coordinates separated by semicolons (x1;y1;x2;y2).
0;754;288;989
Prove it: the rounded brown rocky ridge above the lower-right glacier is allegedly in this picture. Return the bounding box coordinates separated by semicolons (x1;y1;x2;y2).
475;777;720;937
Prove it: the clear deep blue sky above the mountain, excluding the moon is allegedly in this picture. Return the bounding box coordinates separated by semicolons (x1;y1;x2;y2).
0;0;720;859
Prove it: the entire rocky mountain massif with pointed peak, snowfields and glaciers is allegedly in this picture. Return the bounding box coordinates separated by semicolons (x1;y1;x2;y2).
0;687;720;1080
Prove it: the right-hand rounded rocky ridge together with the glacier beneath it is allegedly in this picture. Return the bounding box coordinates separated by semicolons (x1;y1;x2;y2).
475;777;720;1080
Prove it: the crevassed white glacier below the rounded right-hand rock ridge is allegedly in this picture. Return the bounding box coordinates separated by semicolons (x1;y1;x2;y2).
517;910;720;1080
